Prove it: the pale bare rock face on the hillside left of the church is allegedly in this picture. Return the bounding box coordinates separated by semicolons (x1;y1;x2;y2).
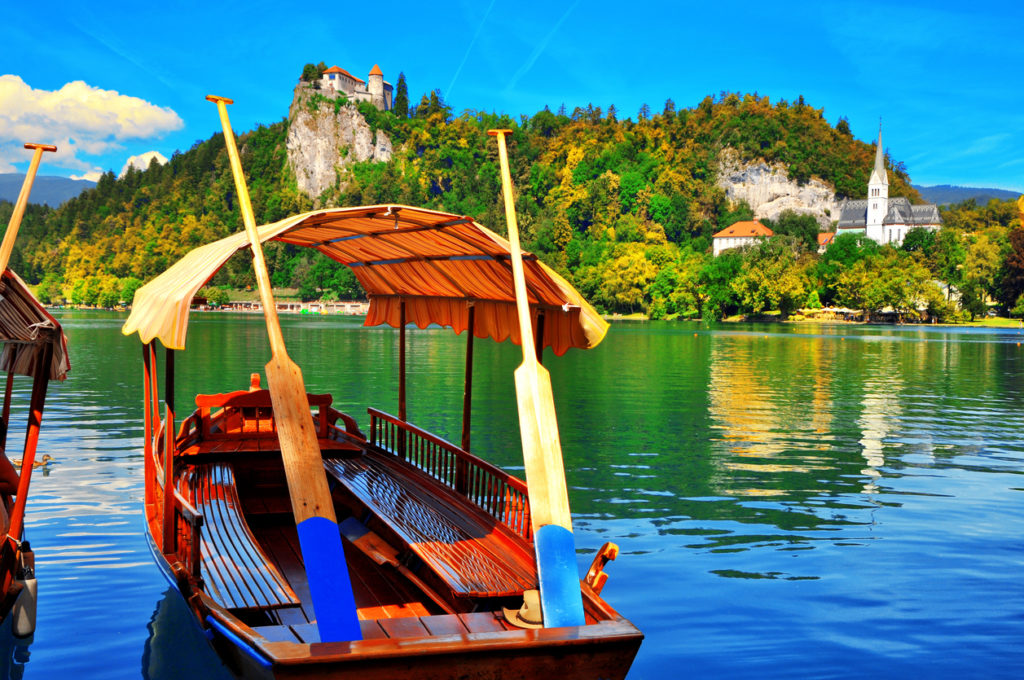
717;148;839;229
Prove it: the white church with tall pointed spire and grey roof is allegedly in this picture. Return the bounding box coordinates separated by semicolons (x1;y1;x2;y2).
836;126;942;246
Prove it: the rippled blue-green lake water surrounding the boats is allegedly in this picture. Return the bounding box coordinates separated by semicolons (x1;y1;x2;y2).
0;312;1024;680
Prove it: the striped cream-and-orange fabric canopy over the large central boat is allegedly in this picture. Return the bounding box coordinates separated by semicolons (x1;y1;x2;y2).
122;205;608;355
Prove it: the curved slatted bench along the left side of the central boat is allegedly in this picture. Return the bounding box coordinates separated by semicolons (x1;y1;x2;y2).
179;463;300;609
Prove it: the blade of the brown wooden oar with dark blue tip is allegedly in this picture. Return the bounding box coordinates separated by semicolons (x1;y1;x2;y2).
266;353;362;642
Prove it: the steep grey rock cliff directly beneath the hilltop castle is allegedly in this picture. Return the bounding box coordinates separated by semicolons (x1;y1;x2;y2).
286;84;392;201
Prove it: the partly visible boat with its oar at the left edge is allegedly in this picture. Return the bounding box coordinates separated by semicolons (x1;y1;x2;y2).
0;143;71;637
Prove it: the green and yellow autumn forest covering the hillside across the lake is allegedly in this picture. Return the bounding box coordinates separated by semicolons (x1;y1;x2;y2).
6;83;1024;322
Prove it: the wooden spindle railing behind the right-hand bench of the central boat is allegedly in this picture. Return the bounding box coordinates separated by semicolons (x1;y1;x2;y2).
368;409;532;541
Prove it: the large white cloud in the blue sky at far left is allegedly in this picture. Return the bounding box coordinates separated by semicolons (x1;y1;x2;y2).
0;75;184;177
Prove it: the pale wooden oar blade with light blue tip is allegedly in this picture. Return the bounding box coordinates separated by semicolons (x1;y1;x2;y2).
515;362;586;628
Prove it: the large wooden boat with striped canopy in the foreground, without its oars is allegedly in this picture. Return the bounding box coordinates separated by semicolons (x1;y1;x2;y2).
123;205;643;679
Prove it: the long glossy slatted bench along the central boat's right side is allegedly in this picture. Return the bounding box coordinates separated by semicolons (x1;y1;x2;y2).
324;452;537;597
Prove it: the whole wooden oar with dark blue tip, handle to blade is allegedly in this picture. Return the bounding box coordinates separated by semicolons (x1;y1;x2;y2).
206;95;362;642
